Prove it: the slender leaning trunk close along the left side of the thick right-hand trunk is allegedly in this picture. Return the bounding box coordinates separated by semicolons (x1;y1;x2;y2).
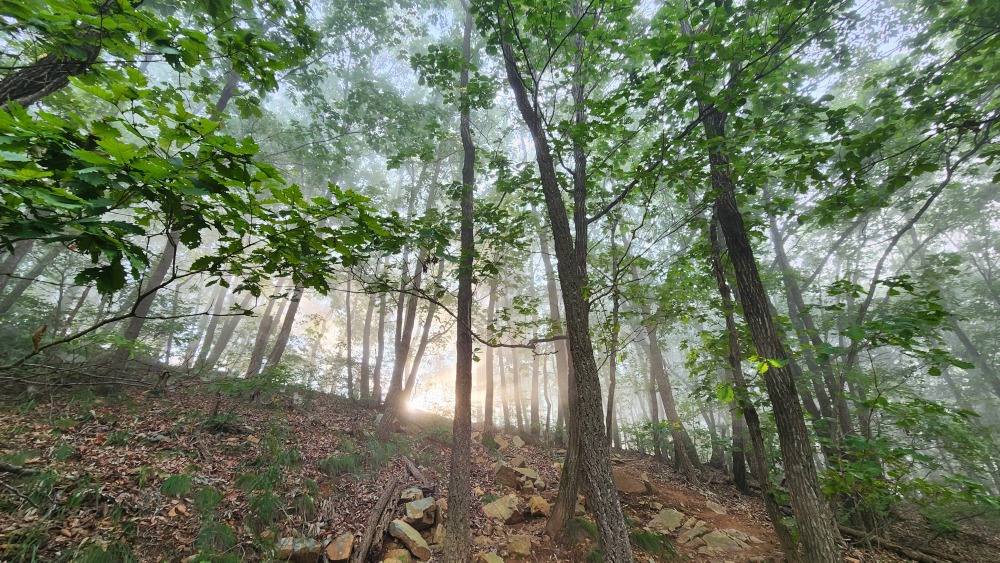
709;220;798;560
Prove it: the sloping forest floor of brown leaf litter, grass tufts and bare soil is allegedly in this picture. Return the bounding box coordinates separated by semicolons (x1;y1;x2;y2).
0;388;1000;563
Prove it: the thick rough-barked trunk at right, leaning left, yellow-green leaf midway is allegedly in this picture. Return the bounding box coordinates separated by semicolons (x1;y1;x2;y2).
699;105;840;562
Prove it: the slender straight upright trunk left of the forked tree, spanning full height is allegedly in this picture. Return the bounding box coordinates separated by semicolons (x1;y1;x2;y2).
441;7;476;563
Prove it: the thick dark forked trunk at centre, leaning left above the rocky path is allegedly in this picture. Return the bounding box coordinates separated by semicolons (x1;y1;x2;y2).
501;37;633;563
